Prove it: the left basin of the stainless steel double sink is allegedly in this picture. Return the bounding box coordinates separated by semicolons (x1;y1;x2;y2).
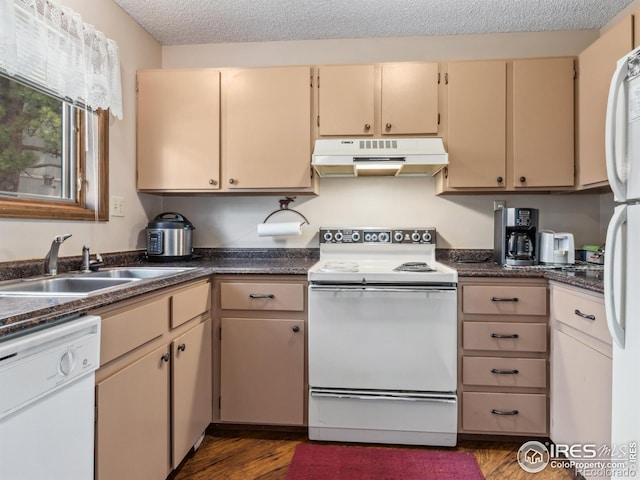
0;276;140;297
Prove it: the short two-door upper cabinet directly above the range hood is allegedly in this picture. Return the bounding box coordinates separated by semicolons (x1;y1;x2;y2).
317;63;438;136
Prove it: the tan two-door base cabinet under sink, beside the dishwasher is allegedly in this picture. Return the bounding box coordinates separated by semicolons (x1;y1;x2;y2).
95;281;212;480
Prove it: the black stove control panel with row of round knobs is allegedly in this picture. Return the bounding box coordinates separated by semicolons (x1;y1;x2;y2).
320;227;436;245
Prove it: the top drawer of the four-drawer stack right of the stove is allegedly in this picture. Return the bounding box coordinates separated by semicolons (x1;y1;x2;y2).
462;285;547;315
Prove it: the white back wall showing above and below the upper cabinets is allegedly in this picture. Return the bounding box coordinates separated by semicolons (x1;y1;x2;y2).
162;31;603;248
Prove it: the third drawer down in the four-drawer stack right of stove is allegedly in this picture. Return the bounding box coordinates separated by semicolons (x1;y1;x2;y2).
462;357;547;388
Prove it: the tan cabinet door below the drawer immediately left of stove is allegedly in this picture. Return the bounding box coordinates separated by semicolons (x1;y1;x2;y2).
220;318;305;425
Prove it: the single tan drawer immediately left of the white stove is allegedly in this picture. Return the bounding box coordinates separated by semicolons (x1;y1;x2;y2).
220;282;304;312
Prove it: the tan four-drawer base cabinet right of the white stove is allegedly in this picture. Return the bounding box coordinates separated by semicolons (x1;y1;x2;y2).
458;278;549;436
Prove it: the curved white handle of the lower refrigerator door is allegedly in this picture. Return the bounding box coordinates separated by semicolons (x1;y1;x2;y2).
604;205;627;349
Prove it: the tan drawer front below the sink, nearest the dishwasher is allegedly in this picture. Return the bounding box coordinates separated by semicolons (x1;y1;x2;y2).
100;297;169;365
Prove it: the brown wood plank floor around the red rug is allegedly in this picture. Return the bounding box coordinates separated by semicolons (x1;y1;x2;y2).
171;430;574;480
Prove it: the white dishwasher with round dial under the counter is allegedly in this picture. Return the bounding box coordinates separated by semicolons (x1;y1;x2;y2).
0;315;100;480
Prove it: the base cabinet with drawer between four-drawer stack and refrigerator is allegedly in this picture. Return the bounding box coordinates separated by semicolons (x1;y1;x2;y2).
549;283;612;480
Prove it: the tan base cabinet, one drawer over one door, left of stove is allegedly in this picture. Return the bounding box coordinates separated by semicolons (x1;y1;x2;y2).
214;275;307;426
